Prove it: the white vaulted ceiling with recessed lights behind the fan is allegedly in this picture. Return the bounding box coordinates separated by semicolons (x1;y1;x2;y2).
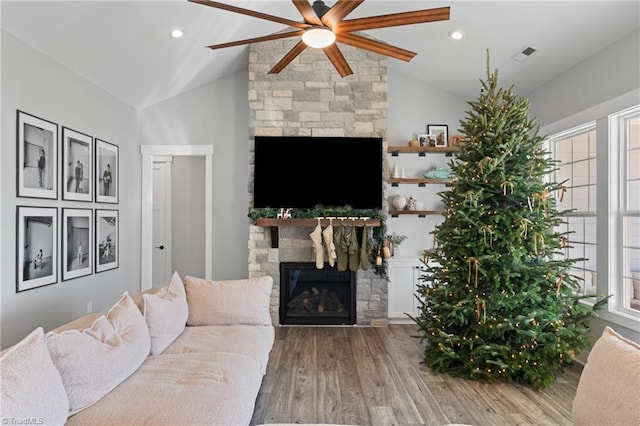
0;0;640;108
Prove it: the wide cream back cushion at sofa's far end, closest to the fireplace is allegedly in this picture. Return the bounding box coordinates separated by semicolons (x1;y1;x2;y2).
184;276;273;325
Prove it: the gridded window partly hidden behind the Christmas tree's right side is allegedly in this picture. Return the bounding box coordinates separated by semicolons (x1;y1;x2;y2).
549;122;597;295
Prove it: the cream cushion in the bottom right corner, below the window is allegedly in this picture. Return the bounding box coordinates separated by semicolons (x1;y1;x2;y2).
572;327;640;426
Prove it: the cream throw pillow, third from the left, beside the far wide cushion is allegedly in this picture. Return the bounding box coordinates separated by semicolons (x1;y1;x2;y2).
142;272;189;355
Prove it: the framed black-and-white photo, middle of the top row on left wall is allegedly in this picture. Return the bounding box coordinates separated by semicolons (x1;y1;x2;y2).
62;127;93;201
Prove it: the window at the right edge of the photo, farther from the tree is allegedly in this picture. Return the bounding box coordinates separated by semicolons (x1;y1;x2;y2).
609;106;640;315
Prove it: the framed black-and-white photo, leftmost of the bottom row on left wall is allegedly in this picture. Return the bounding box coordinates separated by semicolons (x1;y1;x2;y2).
16;206;58;293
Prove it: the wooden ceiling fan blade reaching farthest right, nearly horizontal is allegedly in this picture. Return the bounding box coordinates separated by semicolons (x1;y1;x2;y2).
336;7;450;33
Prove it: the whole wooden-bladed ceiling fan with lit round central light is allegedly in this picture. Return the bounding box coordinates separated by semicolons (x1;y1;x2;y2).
189;0;449;77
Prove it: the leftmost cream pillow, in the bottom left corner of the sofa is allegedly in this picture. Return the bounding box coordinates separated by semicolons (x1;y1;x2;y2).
0;327;69;425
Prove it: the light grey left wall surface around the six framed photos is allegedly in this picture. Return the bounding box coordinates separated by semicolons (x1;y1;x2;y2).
0;32;140;348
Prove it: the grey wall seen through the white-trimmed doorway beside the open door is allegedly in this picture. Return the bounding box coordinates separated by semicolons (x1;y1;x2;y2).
171;157;205;277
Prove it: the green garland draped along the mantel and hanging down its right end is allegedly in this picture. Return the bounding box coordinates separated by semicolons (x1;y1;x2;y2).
249;207;388;278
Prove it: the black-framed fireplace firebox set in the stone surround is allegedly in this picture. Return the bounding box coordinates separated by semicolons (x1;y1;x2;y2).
280;262;356;325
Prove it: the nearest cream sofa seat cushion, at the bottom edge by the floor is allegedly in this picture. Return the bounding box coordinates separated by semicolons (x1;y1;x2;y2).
67;353;262;426
